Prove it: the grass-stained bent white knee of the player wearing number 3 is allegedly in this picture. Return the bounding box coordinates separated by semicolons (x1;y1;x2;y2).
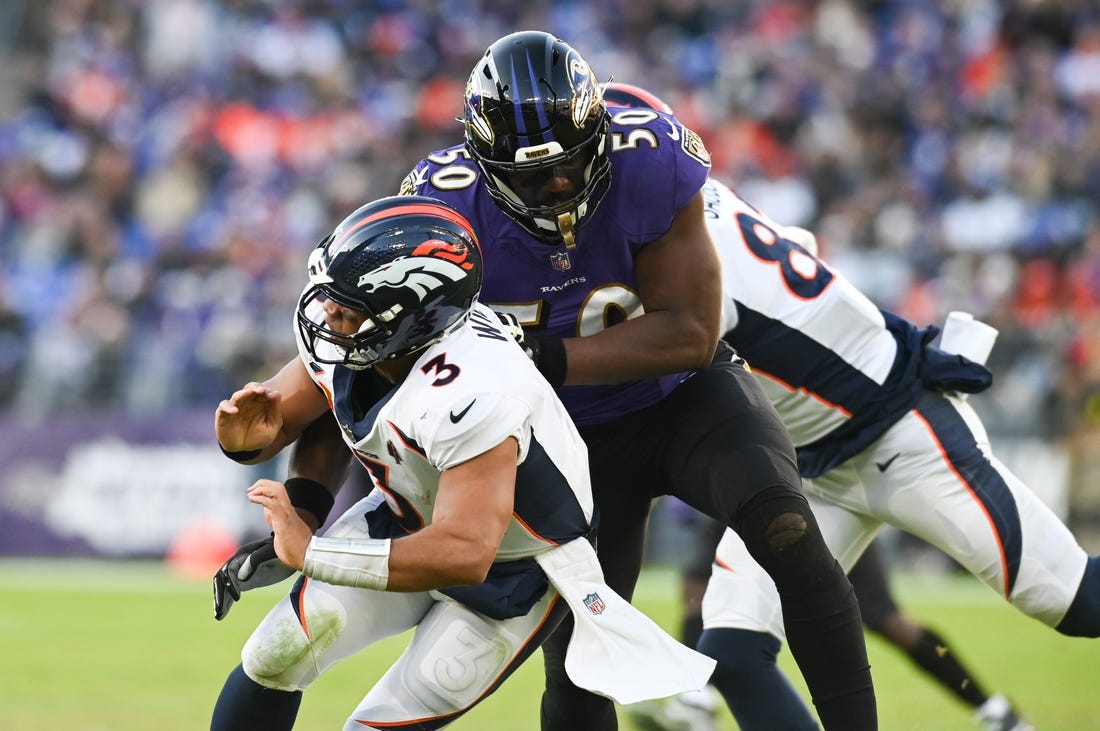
241;598;348;690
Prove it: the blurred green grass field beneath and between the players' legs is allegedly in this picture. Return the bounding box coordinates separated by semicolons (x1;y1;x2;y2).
0;560;1100;731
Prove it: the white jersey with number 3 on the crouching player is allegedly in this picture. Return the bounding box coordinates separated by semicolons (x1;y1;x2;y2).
299;304;593;561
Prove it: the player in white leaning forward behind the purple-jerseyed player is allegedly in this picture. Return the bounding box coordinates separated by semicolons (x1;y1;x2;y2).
605;85;1100;730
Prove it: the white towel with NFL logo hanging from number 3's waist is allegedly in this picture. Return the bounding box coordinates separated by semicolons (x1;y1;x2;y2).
535;539;715;705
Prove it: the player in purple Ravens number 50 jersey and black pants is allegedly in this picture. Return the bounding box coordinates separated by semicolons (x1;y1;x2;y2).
212;31;878;731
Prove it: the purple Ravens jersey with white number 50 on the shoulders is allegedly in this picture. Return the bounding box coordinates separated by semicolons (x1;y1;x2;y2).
400;108;710;424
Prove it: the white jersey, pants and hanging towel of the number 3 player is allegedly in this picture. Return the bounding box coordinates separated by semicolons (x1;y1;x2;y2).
242;302;714;728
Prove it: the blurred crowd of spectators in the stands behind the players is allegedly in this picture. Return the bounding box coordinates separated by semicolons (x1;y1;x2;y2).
0;0;1100;534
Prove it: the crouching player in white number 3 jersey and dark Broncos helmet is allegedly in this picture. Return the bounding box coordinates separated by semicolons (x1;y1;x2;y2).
204;197;714;731
